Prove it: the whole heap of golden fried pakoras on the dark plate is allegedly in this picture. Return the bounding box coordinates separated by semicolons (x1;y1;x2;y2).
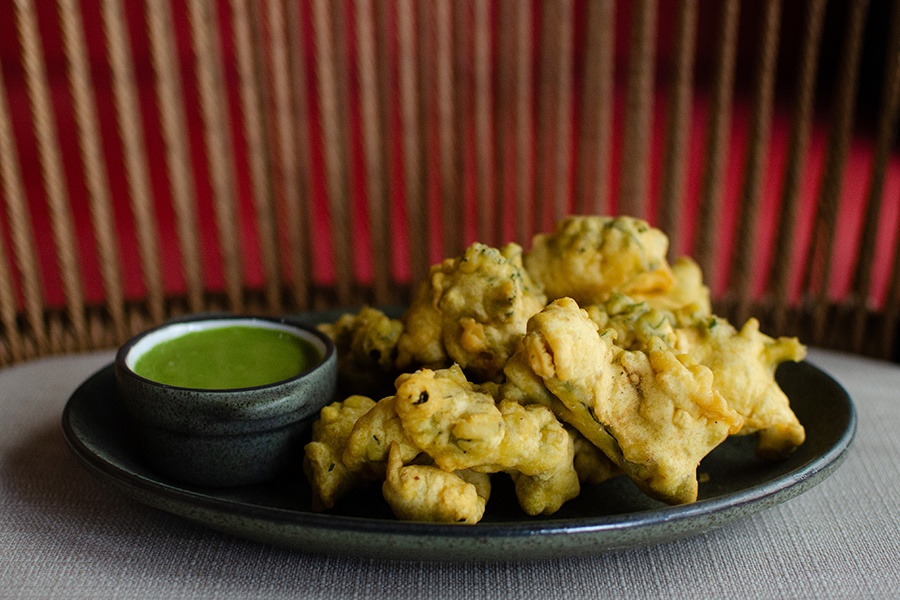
303;216;806;523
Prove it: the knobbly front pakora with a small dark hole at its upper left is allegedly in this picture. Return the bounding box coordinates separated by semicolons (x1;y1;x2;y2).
396;366;580;514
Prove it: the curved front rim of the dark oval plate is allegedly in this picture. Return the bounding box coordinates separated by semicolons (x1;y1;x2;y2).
61;360;857;561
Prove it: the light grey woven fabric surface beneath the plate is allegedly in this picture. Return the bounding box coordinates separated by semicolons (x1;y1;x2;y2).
0;349;900;600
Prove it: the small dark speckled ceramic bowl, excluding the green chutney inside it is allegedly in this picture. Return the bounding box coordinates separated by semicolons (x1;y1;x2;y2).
115;316;337;487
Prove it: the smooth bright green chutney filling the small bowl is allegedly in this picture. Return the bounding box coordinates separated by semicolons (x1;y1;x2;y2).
133;325;321;389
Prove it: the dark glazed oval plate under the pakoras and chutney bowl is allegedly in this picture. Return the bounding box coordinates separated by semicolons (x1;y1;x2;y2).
62;352;856;561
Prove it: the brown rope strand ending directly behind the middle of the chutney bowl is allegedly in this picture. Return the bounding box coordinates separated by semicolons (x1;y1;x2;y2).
188;0;244;312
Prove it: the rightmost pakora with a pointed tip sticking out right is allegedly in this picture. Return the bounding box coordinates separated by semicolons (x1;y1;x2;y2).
676;317;806;460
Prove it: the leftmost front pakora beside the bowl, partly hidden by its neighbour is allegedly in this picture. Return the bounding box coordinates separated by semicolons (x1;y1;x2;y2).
303;396;375;510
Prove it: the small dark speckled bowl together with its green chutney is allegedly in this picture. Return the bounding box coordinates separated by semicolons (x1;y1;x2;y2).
115;316;337;487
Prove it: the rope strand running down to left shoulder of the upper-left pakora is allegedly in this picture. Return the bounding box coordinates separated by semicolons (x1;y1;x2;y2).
397;0;429;281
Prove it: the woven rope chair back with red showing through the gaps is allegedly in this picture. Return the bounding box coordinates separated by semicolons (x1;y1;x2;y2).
0;0;900;365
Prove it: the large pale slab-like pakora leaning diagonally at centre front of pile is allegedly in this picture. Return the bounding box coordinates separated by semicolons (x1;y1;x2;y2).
510;298;742;503
